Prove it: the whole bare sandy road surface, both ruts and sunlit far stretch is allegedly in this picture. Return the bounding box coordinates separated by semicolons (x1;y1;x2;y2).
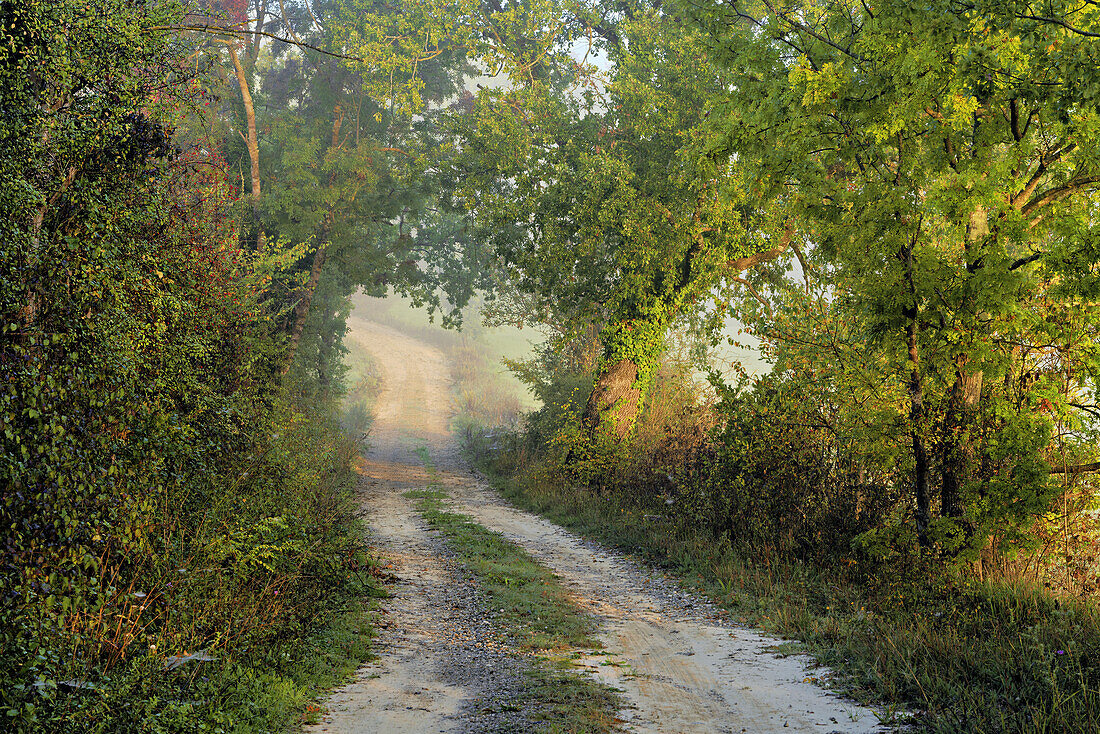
310;318;886;734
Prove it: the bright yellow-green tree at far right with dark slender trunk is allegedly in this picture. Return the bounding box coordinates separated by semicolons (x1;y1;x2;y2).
684;0;1100;548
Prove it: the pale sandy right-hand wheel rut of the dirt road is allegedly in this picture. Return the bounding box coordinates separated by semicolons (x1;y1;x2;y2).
437;448;892;734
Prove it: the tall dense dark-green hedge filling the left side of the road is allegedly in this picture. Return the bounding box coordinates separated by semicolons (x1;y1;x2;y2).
0;0;366;732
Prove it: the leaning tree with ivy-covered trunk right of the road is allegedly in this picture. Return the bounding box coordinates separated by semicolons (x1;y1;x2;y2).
442;3;789;438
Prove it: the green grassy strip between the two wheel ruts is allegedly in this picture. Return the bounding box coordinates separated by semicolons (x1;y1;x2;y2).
407;452;622;733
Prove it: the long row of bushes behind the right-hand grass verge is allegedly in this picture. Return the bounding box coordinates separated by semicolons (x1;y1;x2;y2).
497;330;1100;581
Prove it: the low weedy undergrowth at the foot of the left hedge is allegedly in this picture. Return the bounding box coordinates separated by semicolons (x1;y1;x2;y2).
0;406;384;733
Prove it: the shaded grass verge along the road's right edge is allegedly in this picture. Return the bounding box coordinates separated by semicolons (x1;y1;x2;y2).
480;448;1100;734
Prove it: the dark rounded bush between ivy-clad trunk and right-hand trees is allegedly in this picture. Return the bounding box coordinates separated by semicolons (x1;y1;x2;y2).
681;376;902;560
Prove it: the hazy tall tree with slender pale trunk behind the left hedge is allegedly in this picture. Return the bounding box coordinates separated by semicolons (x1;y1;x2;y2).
194;0;490;390
